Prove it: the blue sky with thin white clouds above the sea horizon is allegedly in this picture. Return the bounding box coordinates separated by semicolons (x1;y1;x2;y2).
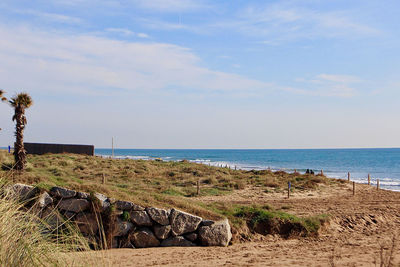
0;0;400;149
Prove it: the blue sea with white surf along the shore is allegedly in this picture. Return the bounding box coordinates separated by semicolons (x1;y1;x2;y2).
95;148;400;191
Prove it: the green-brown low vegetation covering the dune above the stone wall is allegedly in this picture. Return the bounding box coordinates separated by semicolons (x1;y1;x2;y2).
0;150;339;239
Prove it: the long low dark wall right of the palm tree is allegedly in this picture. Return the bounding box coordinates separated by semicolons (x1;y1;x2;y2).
24;143;94;156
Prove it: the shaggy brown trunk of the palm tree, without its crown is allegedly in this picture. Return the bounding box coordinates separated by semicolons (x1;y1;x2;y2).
14;107;26;170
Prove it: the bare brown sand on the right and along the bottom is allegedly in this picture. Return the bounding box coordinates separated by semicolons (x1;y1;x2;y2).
79;184;400;266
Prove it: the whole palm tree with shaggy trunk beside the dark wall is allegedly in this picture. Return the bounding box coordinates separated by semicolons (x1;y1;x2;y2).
9;93;33;170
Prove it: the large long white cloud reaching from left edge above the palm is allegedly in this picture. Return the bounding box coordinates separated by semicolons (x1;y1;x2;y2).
0;26;270;97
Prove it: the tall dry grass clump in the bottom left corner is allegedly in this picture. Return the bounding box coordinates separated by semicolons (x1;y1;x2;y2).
0;177;94;266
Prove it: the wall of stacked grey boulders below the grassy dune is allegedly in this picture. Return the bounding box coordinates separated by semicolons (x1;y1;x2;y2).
10;184;232;248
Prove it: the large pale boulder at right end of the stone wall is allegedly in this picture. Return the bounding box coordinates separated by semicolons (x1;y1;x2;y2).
199;220;232;247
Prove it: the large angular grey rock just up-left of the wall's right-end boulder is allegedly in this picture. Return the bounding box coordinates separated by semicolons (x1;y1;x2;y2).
169;209;202;235
